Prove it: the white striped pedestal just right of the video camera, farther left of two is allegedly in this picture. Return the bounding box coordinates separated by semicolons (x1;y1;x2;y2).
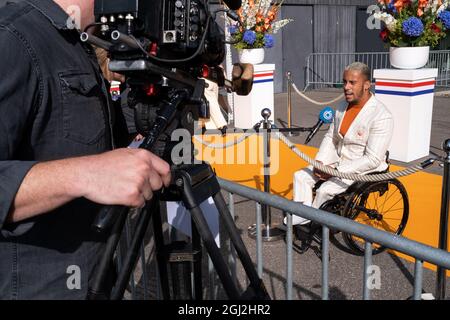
234;64;275;129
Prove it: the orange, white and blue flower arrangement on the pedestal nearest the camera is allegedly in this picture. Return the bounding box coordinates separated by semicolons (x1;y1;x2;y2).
229;0;293;50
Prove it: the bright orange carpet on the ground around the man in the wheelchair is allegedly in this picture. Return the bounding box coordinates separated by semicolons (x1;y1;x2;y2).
193;134;450;276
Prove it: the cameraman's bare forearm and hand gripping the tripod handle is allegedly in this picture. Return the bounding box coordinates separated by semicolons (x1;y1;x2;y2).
8;149;171;222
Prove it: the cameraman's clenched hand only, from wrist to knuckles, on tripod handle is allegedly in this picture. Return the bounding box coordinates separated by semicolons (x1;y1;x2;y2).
80;149;171;208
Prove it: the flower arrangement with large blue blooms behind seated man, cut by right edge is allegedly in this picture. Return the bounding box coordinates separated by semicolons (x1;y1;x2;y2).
373;0;450;47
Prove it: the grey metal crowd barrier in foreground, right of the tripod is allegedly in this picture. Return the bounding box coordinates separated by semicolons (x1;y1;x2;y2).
219;179;450;300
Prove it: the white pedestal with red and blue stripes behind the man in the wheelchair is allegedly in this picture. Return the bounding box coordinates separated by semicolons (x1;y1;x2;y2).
373;69;438;162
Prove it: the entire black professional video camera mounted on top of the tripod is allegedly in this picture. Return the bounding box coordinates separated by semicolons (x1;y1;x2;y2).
82;0;253;144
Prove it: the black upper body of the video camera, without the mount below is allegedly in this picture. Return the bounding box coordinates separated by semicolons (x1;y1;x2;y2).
94;0;225;67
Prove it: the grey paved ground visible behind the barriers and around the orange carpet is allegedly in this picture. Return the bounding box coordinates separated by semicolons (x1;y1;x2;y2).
125;91;450;300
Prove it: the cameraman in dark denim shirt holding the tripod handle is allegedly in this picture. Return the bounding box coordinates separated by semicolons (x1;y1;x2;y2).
0;0;171;299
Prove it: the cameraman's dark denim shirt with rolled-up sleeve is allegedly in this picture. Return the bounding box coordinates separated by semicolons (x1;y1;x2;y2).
0;0;123;299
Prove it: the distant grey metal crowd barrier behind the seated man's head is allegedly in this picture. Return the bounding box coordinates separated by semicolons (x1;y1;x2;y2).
304;50;450;91
